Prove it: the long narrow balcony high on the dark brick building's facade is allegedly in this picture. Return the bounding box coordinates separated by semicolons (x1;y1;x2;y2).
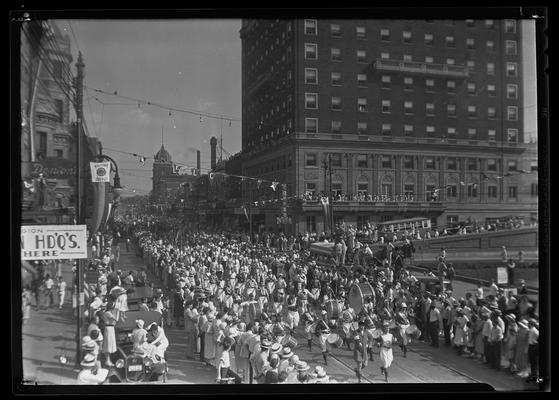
373;59;470;78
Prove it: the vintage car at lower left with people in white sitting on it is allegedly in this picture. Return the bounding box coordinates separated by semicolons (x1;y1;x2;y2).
107;311;168;383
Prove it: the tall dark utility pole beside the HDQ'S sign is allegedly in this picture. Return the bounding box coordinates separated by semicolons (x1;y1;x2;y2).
74;52;85;367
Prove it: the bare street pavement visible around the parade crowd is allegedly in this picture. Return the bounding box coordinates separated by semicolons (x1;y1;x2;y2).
22;241;534;391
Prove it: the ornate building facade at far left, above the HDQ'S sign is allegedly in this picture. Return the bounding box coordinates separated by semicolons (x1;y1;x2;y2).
20;20;99;223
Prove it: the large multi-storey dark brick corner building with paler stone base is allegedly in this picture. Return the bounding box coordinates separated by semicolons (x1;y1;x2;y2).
240;19;538;233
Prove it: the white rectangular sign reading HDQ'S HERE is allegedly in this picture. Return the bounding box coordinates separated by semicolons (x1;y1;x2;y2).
21;225;87;260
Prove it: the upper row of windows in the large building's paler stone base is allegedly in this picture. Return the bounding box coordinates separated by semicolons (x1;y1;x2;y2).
305;153;538;173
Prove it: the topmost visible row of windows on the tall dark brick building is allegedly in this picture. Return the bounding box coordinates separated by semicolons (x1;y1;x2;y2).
304;19;516;39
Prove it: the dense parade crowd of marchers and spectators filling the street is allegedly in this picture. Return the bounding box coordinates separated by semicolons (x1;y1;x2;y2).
73;215;539;384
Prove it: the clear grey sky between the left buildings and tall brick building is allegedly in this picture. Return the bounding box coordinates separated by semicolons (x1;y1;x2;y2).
55;19;241;194
